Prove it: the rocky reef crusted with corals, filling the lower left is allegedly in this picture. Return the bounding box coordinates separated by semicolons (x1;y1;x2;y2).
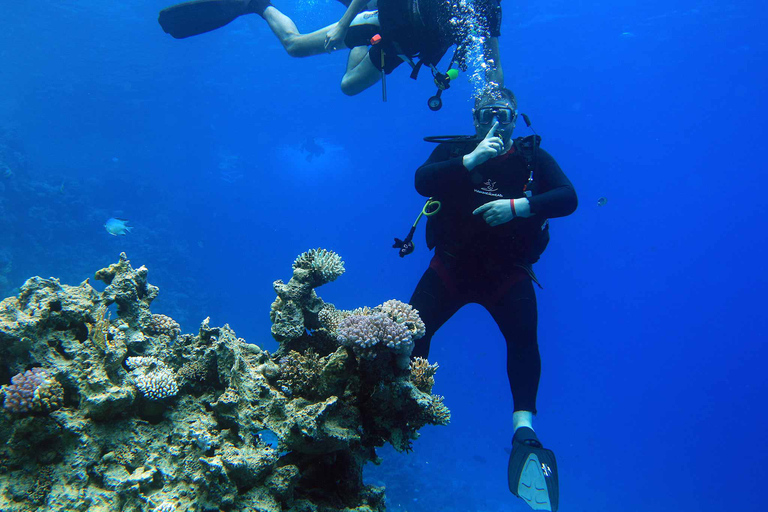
0;249;450;512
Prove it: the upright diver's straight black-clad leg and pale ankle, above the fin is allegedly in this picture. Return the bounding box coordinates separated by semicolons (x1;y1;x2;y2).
486;279;541;418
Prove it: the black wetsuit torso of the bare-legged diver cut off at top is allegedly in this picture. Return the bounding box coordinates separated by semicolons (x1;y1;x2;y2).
368;0;501;74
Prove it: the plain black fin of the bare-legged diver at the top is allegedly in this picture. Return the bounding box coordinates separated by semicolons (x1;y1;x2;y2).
157;0;252;39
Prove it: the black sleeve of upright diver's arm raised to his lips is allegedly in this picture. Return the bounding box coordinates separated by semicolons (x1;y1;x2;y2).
415;144;472;197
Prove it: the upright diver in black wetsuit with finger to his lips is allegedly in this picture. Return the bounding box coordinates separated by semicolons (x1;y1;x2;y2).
408;89;577;512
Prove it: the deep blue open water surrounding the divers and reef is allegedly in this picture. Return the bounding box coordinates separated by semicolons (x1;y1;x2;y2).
0;0;768;512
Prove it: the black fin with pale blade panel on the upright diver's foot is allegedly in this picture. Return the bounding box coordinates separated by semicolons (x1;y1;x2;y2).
507;427;560;512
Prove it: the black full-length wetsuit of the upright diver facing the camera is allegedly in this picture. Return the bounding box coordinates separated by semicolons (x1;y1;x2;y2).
411;138;577;412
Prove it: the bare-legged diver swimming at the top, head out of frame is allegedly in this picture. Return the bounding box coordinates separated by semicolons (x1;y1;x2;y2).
158;0;504;101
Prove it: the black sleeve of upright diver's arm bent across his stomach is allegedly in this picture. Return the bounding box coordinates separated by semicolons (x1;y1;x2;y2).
528;149;578;219
